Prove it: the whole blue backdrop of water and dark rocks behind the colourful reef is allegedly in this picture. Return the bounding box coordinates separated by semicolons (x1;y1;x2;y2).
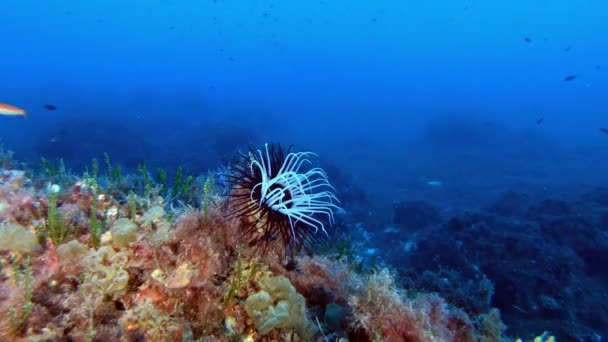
0;0;608;341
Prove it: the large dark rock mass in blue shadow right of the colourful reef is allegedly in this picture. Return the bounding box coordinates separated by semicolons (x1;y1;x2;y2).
394;211;608;336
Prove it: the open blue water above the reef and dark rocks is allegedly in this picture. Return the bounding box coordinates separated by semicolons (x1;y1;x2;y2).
0;0;608;336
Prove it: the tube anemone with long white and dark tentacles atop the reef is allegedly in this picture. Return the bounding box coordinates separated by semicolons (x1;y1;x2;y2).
225;144;342;255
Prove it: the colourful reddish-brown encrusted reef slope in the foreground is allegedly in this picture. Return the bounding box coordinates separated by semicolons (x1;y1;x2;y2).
0;148;524;341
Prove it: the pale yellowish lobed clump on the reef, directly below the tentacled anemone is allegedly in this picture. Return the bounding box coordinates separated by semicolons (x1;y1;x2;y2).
245;276;317;340
